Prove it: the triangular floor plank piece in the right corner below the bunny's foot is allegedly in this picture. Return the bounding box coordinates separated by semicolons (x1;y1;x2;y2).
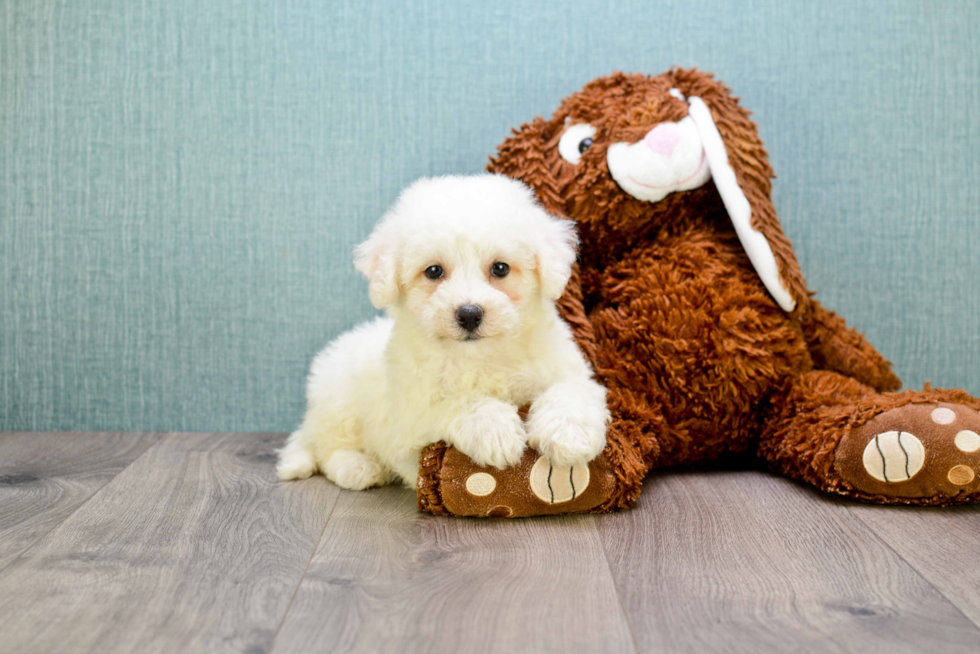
853;504;980;626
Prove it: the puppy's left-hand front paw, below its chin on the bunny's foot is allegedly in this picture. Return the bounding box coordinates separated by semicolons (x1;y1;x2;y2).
452;400;527;470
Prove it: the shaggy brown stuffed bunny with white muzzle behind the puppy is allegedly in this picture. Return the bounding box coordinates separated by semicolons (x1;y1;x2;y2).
419;69;980;516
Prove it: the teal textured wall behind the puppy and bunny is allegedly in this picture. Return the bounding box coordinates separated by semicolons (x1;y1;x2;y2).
0;0;980;430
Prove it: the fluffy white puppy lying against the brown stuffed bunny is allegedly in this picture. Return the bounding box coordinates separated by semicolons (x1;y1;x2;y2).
277;175;609;490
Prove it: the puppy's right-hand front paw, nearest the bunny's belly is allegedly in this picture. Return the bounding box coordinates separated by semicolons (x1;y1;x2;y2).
527;379;609;466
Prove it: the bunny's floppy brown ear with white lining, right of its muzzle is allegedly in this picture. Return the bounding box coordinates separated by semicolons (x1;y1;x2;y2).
679;71;810;312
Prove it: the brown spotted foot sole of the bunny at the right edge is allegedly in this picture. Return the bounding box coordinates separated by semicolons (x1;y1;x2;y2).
835;403;980;499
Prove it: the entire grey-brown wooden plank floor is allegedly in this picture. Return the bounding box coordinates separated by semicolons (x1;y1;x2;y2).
0;433;980;654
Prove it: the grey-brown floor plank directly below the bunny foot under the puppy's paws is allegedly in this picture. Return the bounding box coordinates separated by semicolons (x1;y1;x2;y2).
272;488;633;654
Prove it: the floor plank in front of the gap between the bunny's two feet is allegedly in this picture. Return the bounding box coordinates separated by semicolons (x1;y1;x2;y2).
598;472;980;654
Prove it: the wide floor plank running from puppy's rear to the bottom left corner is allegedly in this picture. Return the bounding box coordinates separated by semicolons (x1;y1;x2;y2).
0;434;338;654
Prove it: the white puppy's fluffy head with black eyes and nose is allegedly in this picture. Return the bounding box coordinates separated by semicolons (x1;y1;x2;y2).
354;175;577;342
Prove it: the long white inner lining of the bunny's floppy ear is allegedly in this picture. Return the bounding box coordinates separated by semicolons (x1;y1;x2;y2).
687;97;796;312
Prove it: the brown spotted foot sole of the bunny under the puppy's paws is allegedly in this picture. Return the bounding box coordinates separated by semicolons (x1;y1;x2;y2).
439;447;616;518
